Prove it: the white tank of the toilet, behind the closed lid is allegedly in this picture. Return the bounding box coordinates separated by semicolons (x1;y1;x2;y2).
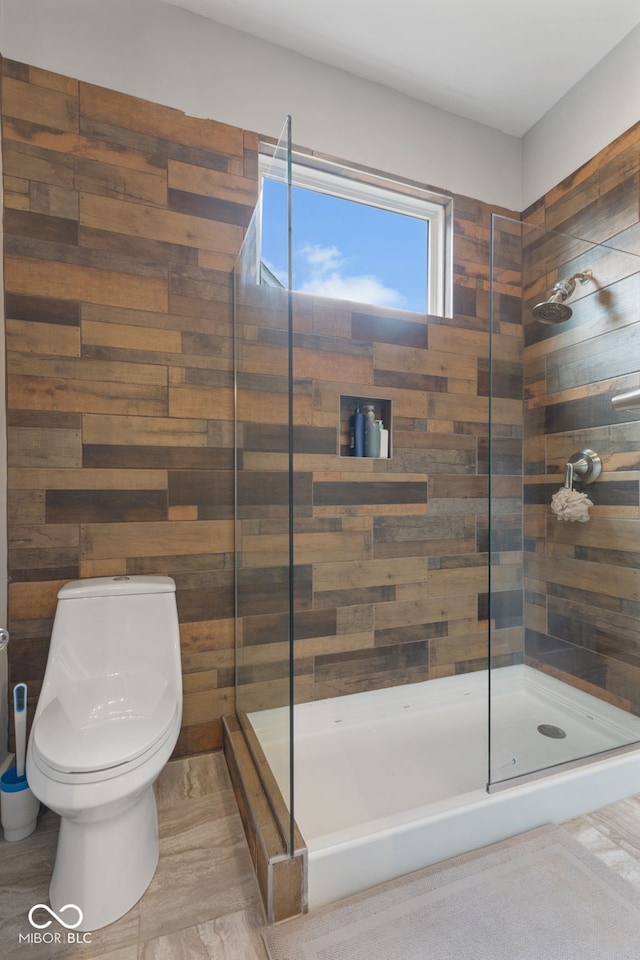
41;576;182;705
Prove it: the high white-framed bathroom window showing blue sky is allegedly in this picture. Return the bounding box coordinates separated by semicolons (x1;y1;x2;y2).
260;153;451;316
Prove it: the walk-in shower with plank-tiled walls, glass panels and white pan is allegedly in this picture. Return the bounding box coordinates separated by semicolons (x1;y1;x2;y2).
235;122;640;907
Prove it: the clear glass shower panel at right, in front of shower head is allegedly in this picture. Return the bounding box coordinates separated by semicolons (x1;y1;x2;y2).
488;216;640;787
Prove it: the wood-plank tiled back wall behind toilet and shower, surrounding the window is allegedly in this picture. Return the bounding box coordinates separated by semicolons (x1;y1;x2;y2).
2;60;521;754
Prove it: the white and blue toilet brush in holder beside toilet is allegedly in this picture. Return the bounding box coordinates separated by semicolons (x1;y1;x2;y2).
0;683;40;840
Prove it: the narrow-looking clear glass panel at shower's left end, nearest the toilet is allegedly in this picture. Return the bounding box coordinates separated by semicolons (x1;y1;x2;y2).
234;119;293;852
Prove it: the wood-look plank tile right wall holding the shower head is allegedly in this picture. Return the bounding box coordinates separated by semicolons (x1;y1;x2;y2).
523;124;640;714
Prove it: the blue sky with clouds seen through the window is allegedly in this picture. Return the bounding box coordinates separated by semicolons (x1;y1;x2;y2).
262;180;427;313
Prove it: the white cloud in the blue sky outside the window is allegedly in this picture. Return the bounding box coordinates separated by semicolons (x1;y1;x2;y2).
294;244;406;308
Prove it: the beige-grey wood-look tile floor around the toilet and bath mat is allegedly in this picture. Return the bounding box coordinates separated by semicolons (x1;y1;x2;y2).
0;753;640;960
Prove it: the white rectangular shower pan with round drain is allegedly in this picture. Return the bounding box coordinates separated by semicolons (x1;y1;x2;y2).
250;666;640;909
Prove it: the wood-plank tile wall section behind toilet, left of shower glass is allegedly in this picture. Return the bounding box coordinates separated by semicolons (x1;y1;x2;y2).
2;59;257;754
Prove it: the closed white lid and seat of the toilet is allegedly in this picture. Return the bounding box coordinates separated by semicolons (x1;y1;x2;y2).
32;673;178;779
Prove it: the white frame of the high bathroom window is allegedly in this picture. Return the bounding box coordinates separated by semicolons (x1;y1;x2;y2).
258;143;453;317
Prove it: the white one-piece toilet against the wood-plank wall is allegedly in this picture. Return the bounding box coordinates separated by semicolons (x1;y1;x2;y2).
26;576;182;930
